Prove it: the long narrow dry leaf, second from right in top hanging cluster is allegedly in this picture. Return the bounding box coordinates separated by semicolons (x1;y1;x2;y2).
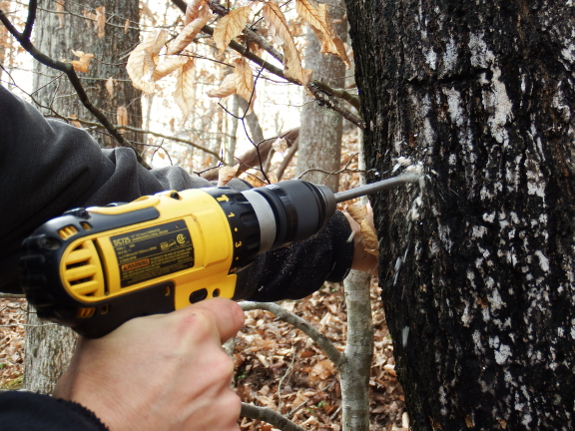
262;2;312;86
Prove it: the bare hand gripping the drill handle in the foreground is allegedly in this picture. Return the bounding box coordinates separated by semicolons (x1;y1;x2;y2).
54;298;249;431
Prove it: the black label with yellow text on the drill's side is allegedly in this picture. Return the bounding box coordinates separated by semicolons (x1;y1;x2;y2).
110;220;194;287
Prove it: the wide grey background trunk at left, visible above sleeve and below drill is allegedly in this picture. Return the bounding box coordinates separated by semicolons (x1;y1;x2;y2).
24;0;142;393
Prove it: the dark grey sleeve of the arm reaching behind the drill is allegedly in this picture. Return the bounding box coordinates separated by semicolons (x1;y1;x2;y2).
0;87;353;300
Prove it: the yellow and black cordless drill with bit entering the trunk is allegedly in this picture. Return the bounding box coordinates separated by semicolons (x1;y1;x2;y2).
20;174;418;338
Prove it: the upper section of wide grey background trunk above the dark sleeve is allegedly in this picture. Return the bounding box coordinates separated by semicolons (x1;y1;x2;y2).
34;0;143;150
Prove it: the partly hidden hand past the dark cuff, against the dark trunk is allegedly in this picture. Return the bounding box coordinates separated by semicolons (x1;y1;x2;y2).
343;204;378;276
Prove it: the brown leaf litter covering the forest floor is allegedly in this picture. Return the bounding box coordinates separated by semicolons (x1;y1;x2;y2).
0;284;408;431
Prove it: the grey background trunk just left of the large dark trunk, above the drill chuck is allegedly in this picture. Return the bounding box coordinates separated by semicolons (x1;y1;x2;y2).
296;0;347;191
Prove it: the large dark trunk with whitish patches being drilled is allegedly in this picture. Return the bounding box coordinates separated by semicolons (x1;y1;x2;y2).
347;0;575;430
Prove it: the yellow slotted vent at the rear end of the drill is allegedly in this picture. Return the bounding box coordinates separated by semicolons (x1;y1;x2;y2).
61;240;104;299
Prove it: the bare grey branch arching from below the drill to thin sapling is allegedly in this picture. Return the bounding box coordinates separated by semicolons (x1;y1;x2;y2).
240;301;343;367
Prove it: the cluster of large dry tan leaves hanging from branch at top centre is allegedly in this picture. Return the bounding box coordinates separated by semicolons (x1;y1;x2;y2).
127;0;349;117
